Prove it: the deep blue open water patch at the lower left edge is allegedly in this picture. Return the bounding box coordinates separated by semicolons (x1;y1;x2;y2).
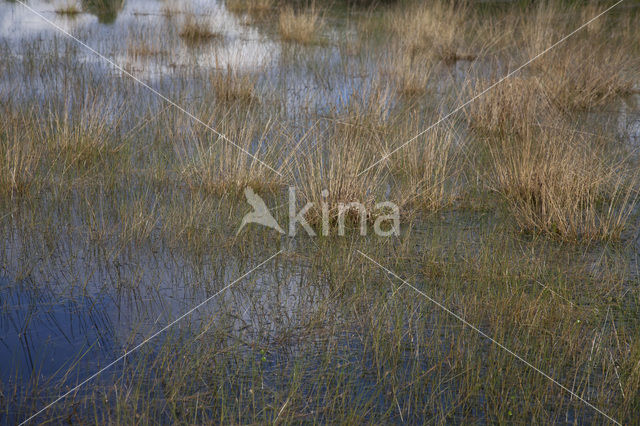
0;278;114;384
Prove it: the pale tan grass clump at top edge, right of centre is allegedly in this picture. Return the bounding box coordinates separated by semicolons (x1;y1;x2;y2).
390;1;473;63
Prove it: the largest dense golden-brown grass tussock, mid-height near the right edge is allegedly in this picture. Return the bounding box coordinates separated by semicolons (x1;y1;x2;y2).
489;129;639;242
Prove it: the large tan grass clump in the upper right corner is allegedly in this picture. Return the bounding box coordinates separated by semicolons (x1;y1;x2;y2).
521;1;640;109
